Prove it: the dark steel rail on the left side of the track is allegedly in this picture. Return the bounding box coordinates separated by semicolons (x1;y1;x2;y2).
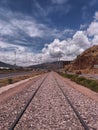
9;75;48;130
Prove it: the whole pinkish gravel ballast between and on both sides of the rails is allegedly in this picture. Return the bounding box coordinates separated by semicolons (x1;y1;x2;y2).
0;72;98;130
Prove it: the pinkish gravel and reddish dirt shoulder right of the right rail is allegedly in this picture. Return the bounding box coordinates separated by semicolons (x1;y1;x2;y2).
56;74;98;130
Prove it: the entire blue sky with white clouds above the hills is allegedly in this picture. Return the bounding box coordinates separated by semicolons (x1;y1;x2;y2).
0;0;98;66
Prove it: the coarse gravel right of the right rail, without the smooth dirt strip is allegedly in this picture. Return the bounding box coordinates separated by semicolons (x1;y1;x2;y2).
56;74;98;130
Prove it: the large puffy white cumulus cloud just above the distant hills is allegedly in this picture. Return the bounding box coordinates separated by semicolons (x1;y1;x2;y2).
39;31;90;60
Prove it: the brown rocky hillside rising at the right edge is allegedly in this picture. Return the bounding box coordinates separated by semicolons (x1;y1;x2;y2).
68;45;98;70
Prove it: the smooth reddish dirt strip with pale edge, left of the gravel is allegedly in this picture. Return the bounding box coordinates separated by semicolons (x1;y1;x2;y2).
0;75;40;102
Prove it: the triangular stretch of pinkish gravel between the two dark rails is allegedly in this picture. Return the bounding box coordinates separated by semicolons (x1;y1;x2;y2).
15;73;84;130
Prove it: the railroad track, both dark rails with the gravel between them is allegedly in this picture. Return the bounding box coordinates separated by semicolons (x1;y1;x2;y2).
1;72;97;130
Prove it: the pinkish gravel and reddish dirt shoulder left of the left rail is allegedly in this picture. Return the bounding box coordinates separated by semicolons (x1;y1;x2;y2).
0;75;45;130
